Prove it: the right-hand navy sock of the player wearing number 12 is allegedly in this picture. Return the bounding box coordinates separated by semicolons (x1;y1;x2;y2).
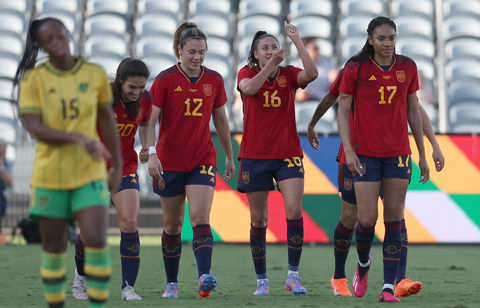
192;225;213;278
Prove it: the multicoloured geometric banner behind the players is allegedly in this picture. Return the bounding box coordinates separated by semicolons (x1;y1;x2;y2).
182;135;480;243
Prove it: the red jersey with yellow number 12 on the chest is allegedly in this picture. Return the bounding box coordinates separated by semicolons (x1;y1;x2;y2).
150;64;227;172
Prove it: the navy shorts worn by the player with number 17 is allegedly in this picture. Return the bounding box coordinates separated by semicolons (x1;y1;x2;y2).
352;155;412;182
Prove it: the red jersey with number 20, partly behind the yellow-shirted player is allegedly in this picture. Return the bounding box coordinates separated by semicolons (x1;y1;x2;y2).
112;91;152;176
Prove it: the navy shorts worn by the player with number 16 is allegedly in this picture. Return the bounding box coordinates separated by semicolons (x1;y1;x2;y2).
237;156;305;192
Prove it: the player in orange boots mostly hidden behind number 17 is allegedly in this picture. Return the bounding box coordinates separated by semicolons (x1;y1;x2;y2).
307;69;445;297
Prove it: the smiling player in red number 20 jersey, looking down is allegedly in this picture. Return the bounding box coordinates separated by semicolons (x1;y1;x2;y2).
72;58;152;301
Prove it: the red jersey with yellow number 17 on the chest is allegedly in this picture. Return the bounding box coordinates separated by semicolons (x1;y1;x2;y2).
340;55;419;157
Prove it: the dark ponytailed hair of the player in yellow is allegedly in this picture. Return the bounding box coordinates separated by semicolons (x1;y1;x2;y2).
12;17;68;103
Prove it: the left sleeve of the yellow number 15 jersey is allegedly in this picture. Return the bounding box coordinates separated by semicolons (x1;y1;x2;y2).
19;71;41;114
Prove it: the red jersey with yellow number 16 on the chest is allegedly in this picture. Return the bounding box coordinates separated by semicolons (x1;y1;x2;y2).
237;65;303;159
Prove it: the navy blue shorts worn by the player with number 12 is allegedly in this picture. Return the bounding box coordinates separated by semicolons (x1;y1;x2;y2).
153;165;217;197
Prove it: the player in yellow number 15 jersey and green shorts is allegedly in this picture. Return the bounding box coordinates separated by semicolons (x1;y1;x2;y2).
14;18;122;307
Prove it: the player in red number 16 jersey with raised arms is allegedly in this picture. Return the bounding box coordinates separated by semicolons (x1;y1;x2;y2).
238;22;318;296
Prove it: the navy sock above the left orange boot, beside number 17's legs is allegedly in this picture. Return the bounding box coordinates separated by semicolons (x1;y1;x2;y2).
333;221;355;279
